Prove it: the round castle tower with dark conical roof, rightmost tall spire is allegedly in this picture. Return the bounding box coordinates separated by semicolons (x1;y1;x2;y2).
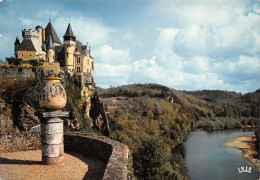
63;23;76;73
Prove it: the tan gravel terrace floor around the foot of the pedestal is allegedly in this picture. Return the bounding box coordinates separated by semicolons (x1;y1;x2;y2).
0;150;106;180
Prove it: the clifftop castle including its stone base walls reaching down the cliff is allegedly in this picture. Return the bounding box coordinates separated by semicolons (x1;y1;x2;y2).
10;20;95;115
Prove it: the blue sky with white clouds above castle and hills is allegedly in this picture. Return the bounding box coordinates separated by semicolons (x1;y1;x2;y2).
0;0;260;93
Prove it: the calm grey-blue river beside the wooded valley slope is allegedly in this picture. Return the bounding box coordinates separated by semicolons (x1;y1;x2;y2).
178;129;260;180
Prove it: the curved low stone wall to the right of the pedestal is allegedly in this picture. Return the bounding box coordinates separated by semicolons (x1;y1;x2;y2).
64;134;128;180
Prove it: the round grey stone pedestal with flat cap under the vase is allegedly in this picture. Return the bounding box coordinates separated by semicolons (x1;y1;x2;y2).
41;111;69;165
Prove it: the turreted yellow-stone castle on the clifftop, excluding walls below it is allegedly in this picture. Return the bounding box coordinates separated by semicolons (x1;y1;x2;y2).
14;21;94;76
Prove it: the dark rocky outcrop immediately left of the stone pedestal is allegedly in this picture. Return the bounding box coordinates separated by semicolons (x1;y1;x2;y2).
18;105;40;131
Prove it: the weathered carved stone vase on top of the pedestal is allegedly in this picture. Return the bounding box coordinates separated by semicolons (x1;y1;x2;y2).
39;76;67;110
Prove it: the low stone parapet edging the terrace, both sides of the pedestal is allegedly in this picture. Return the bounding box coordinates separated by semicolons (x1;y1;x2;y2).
0;133;129;180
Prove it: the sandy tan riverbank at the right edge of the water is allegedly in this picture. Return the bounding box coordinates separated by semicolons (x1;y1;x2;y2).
225;135;260;171
